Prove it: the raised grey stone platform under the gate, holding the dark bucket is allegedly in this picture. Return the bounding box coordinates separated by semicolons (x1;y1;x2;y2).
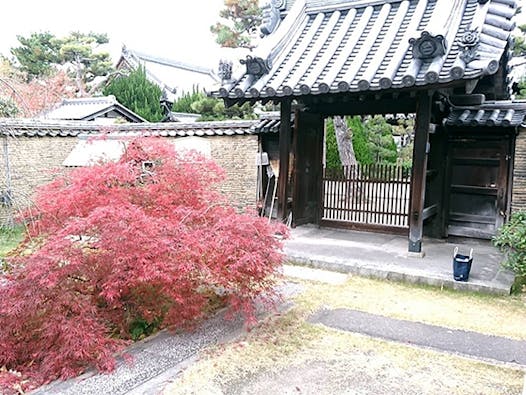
284;225;514;295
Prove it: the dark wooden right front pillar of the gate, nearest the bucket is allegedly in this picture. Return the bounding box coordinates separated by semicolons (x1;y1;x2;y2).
409;91;431;253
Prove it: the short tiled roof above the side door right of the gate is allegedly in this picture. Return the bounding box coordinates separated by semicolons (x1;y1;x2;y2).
445;100;526;127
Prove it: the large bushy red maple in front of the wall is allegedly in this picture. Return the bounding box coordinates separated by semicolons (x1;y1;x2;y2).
0;138;286;391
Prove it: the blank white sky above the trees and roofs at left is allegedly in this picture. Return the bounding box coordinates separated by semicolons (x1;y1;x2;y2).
0;0;241;68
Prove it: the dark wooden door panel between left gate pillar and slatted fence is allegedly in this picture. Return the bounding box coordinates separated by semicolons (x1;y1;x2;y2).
292;111;323;225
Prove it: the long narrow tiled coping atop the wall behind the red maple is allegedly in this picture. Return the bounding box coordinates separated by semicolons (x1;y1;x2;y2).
0;118;266;137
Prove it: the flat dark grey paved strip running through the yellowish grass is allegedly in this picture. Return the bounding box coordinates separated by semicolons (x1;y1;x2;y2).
309;309;526;367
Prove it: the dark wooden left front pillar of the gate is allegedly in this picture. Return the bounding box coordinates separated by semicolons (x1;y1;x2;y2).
278;100;292;220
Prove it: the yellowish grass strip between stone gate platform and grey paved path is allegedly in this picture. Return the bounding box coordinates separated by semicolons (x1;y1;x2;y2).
298;276;526;340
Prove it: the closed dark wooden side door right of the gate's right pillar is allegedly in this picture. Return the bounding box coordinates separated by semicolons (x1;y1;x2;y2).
446;136;510;239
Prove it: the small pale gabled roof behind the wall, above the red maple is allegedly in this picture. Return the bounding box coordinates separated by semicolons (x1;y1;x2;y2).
43;95;146;122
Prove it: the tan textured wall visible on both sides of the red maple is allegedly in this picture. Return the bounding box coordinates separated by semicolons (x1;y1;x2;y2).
0;135;258;226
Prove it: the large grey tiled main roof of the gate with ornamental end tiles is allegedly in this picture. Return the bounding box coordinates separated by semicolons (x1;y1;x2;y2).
211;0;517;101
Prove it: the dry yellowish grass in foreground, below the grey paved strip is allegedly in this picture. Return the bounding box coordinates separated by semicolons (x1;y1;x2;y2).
164;296;523;395
